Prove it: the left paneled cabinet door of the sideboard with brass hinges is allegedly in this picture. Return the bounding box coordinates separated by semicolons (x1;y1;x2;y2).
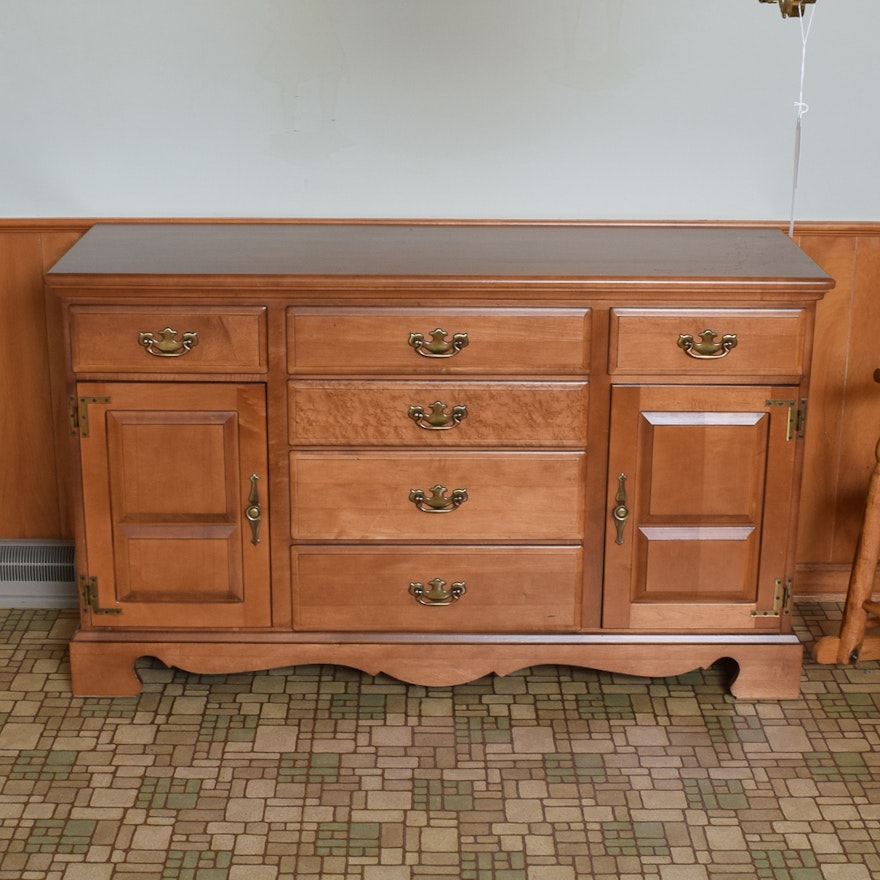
77;383;271;629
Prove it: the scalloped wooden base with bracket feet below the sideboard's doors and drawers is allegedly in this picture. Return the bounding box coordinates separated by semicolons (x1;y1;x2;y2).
70;633;804;700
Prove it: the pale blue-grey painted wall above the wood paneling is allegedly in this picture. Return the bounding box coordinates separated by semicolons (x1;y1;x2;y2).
0;0;880;221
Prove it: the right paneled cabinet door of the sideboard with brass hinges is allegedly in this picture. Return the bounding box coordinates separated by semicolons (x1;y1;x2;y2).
603;386;798;632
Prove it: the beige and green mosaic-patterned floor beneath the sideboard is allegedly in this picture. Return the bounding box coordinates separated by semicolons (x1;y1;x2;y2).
0;603;880;880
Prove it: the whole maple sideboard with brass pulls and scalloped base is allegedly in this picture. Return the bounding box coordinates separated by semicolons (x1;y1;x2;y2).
46;222;833;699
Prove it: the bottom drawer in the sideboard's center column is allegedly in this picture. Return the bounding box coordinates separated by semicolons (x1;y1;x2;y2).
292;546;582;633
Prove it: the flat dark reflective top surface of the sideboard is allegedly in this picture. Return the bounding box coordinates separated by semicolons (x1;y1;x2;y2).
49;222;833;289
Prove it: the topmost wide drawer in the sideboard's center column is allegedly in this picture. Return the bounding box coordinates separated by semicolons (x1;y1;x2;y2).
287;308;590;375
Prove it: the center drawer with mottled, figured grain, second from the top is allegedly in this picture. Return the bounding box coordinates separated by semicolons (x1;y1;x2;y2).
288;380;587;449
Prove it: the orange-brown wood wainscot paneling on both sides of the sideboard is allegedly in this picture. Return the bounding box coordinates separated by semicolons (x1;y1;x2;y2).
0;220;880;596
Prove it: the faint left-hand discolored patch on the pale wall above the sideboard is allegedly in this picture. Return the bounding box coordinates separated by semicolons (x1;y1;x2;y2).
258;0;351;162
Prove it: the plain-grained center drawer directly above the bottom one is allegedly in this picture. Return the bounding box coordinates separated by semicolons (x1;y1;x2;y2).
290;452;585;543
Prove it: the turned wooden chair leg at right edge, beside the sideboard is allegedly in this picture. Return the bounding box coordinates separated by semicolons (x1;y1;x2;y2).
813;442;880;663
